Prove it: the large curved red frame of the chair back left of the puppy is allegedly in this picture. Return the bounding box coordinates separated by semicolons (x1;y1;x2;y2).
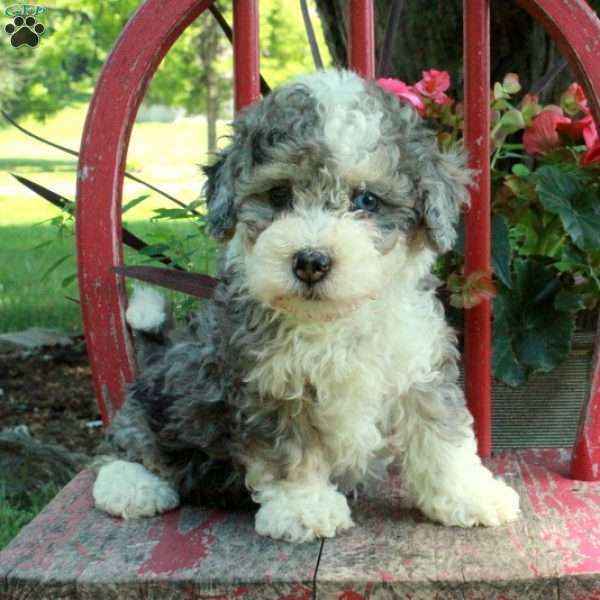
76;0;213;424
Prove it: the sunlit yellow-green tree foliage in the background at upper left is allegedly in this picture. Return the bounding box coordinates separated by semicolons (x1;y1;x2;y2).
0;0;327;126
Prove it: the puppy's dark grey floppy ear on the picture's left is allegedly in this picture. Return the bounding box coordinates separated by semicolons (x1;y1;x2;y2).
202;148;236;240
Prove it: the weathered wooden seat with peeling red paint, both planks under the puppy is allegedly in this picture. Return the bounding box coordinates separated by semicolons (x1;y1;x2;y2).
0;449;600;600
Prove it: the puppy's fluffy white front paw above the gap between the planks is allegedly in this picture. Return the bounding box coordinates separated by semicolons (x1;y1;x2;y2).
255;488;354;542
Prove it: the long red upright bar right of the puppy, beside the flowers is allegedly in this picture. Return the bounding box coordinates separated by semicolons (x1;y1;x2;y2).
463;0;492;457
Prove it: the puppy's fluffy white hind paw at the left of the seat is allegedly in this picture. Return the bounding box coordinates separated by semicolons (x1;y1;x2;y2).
93;460;179;519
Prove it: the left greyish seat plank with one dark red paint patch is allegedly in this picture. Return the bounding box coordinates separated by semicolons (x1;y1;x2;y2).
0;472;320;600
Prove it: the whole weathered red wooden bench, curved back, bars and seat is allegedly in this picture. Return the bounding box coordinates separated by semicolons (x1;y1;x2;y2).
0;0;600;600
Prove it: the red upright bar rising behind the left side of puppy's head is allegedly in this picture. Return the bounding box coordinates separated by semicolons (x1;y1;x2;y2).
233;0;258;112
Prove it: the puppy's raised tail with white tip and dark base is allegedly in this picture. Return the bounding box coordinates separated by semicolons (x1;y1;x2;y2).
125;287;174;367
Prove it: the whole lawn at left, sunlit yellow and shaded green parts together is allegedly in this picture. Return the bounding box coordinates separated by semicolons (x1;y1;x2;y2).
0;104;226;332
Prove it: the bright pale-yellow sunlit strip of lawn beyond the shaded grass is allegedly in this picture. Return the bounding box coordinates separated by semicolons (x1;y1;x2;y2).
0;105;227;227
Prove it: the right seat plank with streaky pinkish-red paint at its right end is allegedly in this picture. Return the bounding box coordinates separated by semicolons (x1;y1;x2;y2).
317;449;600;600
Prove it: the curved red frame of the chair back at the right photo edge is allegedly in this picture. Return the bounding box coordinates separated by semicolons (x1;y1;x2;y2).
518;0;600;481
